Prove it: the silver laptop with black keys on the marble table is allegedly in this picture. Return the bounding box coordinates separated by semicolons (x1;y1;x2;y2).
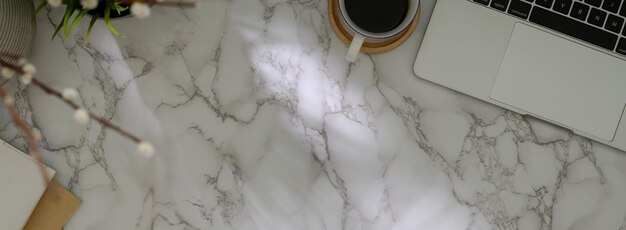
415;0;626;150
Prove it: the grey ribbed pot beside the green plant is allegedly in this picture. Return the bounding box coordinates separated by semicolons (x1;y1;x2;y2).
0;0;35;85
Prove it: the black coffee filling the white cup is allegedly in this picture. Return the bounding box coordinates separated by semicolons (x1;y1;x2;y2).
345;0;409;33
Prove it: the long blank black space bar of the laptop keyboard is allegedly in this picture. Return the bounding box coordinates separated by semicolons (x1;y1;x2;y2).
529;7;617;50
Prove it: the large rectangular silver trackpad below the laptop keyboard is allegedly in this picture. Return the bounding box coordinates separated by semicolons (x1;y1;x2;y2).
491;23;626;141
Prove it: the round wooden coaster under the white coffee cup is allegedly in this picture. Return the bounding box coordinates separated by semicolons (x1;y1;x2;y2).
328;0;421;54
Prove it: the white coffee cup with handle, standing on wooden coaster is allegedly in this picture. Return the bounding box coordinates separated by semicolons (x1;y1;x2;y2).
337;0;419;62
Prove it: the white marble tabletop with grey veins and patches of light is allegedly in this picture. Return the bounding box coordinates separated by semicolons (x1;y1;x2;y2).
0;0;626;230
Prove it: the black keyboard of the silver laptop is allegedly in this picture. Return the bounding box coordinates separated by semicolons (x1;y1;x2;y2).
469;0;626;55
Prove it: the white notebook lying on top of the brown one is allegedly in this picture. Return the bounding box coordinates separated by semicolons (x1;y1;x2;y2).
0;140;55;230
